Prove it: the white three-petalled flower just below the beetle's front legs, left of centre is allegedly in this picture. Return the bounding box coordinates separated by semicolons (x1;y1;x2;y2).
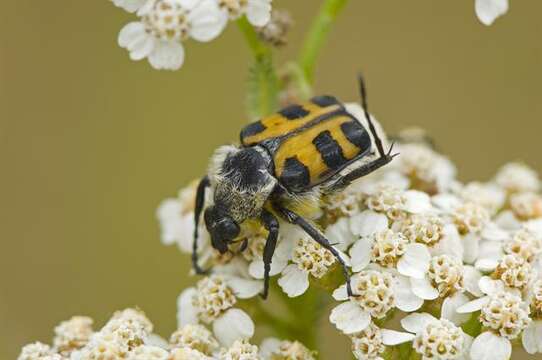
177;275;262;346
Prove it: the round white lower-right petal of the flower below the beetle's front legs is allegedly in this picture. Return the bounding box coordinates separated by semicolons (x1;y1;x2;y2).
213;308;254;347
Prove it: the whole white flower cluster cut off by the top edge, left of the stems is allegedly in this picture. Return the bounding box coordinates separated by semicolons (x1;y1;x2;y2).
112;0;272;70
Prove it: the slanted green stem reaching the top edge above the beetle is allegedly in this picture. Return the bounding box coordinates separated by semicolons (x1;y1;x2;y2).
299;0;348;84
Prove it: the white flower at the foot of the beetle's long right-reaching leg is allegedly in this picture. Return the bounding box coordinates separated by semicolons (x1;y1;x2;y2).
329;270;395;334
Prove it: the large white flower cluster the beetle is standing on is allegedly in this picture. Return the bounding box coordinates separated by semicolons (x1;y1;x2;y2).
158;105;542;360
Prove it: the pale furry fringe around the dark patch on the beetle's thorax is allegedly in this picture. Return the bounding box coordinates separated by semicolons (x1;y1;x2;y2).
208;145;277;223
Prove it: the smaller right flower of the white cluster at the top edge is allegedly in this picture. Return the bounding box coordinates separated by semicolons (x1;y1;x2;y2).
218;0;272;26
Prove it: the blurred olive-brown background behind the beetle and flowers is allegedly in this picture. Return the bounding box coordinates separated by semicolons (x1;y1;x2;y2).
0;0;542;359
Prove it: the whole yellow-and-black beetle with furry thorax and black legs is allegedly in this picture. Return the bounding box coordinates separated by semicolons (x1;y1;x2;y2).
192;76;395;299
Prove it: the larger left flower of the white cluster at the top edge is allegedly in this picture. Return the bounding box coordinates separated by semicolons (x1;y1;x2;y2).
118;0;227;70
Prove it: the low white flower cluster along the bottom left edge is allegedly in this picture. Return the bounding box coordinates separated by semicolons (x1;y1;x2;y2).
18;309;315;360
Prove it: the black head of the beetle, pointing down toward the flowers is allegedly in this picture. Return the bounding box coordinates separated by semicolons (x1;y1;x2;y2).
204;206;241;254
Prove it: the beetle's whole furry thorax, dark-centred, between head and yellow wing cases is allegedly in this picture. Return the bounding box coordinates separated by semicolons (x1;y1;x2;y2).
209;146;277;223
